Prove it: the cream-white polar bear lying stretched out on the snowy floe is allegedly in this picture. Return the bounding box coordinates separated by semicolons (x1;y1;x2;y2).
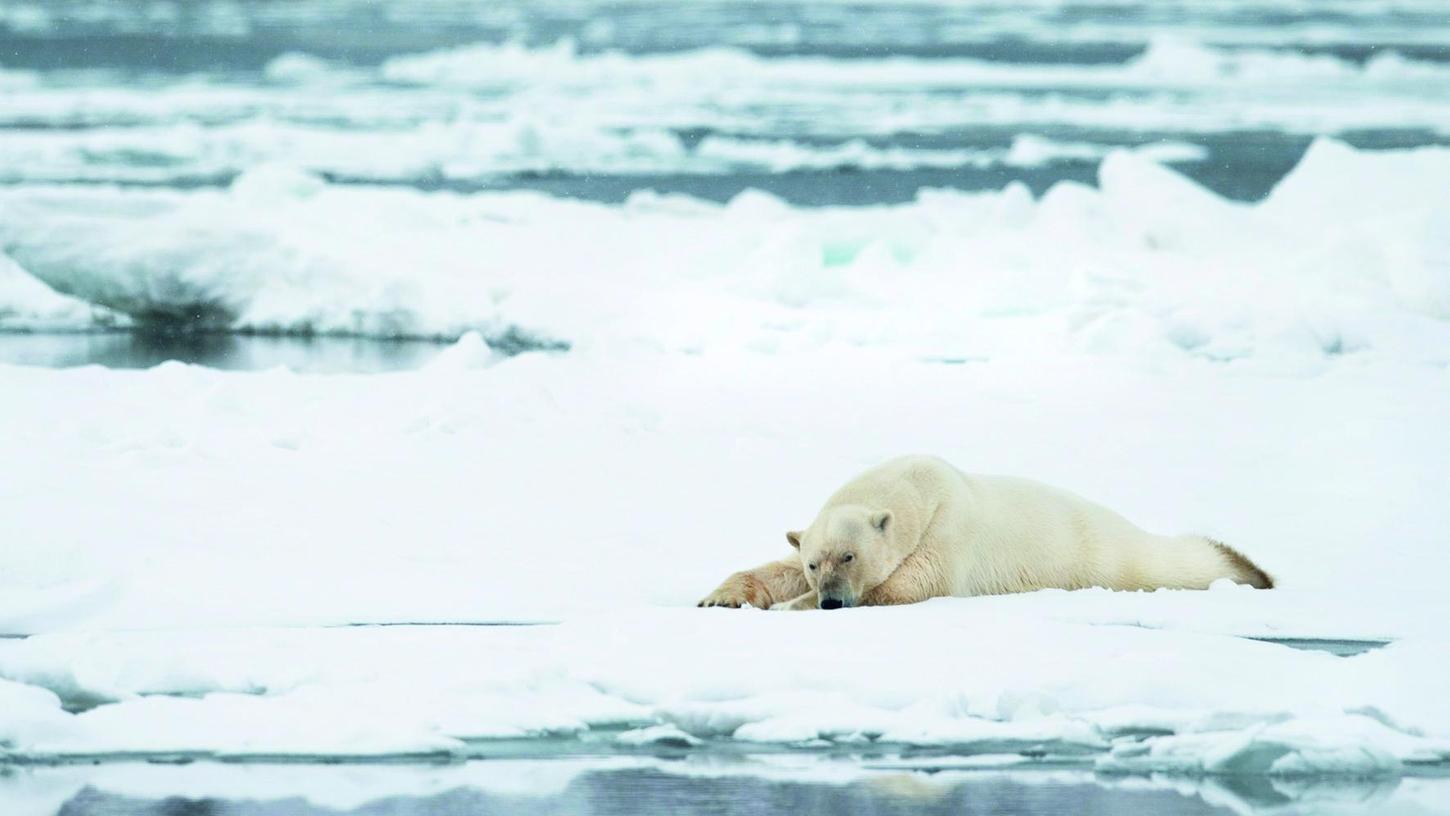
699;457;1273;609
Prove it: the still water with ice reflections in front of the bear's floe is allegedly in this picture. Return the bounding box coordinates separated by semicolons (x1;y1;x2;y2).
0;757;1450;816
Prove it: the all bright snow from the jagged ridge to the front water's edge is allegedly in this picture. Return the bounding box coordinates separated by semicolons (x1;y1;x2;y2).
0;107;1450;780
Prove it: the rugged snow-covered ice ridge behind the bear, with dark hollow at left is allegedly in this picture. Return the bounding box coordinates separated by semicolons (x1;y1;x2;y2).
0;142;1450;363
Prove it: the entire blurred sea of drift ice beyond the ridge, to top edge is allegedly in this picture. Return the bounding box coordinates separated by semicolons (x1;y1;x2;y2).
0;29;1450;199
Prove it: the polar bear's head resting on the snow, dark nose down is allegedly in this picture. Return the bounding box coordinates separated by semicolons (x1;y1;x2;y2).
786;504;900;609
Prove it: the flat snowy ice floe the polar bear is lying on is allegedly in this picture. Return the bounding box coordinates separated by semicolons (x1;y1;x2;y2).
0;336;1450;777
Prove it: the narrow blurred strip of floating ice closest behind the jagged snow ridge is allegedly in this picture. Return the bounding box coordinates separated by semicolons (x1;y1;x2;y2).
0;120;1208;187
